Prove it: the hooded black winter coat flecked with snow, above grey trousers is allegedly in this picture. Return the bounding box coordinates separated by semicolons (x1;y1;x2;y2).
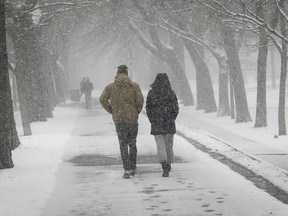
146;74;179;135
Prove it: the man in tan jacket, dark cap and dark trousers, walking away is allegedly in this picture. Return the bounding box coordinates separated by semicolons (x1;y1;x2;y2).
99;65;144;179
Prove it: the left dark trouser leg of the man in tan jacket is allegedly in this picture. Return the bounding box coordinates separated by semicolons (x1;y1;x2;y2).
115;124;130;171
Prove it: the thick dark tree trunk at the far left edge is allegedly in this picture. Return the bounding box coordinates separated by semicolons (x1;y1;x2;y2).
0;0;18;169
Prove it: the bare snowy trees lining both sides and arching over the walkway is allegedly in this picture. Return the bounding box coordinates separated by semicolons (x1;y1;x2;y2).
0;0;288;168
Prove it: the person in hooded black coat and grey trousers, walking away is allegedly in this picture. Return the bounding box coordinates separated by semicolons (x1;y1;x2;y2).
146;73;179;177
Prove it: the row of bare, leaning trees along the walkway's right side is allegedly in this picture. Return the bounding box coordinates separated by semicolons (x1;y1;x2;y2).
81;0;288;132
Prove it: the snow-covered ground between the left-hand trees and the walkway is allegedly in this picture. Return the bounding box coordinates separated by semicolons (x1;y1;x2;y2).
0;107;78;216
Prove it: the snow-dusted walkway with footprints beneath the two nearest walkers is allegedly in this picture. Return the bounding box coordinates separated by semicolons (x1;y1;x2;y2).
42;104;288;216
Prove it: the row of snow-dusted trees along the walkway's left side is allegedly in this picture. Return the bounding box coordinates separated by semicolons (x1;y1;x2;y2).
0;0;89;169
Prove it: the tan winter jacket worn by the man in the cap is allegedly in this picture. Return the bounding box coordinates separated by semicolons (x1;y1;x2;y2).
99;74;144;123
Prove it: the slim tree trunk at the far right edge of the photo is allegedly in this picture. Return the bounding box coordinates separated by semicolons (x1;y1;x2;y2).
278;0;287;135
